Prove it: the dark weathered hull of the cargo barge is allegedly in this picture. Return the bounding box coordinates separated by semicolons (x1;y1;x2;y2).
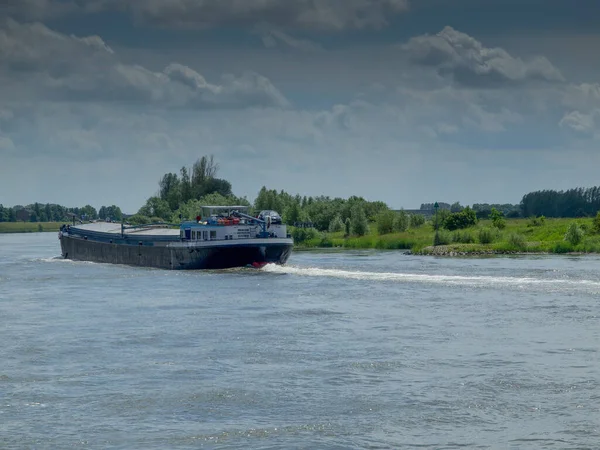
60;236;293;270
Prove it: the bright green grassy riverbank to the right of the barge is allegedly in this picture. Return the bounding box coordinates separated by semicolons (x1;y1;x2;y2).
297;218;600;255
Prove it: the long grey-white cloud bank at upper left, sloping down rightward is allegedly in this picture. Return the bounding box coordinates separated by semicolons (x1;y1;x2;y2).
0;20;289;108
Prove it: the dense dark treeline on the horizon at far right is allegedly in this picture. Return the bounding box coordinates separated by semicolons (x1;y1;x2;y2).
520;187;600;217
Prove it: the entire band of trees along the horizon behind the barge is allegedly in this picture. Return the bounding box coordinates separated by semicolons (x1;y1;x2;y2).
7;156;600;227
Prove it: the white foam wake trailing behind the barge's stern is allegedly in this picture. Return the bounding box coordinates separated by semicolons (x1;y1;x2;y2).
262;264;600;289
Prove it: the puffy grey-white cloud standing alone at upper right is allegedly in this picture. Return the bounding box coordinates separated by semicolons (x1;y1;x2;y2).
402;26;565;87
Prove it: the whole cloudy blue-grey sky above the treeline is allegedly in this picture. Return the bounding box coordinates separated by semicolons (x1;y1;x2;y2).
0;0;600;213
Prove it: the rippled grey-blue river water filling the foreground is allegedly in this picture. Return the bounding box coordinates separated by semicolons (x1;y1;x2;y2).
0;233;600;449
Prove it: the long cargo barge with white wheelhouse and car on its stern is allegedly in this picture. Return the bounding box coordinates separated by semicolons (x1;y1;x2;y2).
58;206;293;270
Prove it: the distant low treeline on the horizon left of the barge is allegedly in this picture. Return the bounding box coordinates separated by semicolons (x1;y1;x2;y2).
0;203;123;222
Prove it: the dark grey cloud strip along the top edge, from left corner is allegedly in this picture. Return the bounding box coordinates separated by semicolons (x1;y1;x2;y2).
0;0;409;31
